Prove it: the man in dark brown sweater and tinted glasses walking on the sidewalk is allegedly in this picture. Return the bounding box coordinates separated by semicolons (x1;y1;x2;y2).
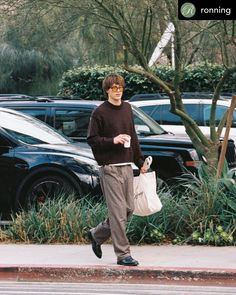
87;74;146;266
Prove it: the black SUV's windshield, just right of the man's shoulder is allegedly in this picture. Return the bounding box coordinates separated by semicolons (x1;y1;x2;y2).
132;106;167;136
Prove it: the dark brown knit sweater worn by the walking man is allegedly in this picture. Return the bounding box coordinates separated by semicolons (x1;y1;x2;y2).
87;101;144;168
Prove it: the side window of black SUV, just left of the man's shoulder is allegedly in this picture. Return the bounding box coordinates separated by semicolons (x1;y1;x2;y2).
54;108;92;137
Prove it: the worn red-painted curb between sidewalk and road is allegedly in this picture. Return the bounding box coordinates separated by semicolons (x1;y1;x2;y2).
0;265;236;286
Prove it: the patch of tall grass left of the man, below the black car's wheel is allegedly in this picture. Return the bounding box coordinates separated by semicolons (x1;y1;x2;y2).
0;196;107;244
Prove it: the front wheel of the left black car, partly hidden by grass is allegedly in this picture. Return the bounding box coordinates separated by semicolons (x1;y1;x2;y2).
20;174;78;209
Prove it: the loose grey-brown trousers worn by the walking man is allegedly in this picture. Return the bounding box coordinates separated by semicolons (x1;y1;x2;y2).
91;165;134;260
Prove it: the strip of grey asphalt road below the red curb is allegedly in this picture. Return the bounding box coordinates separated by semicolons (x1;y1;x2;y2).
0;282;236;295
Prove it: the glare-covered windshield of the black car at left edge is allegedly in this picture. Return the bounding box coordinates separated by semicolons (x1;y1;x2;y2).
0;110;70;144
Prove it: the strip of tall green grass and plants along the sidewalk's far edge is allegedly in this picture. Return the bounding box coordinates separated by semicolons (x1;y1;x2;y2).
0;168;236;246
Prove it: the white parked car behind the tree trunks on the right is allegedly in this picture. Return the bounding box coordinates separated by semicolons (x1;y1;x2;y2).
132;99;236;143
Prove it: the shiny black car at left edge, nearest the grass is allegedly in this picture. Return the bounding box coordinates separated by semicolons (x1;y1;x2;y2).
0;108;100;218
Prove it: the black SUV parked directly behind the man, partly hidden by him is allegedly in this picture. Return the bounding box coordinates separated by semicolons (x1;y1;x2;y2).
0;97;236;180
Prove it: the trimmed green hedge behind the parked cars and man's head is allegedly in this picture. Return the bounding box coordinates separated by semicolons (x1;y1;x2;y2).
59;64;236;100
